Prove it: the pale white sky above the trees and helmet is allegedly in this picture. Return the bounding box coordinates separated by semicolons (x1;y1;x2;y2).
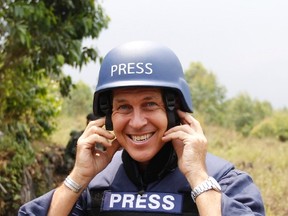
64;0;288;108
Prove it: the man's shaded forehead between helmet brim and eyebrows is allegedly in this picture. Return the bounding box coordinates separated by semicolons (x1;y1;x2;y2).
112;87;161;98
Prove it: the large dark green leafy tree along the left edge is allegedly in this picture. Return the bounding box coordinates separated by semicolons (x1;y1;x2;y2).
0;0;109;215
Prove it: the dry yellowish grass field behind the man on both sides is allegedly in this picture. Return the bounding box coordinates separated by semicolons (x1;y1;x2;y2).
52;118;288;216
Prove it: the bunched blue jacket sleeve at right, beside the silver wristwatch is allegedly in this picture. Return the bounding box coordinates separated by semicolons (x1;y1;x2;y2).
219;169;265;216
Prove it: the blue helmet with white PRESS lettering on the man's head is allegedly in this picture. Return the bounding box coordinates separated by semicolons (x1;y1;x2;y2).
93;41;193;129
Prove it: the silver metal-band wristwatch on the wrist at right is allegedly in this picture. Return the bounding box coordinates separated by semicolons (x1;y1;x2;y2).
191;176;221;202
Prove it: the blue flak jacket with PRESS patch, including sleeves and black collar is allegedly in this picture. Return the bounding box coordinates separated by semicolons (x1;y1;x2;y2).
18;146;265;216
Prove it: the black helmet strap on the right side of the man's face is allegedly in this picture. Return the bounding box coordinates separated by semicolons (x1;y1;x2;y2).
163;90;180;130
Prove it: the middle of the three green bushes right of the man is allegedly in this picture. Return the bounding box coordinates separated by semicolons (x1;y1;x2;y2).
225;94;273;136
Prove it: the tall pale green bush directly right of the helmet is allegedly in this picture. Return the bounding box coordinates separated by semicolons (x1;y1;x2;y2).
185;62;226;124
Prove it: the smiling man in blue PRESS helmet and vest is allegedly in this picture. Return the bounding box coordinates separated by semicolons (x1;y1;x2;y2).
19;41;264;216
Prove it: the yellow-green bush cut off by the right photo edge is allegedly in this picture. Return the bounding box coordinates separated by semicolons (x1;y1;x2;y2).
251;111;288;142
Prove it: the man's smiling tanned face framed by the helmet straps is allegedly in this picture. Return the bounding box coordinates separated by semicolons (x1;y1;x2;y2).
112;88;168;164
